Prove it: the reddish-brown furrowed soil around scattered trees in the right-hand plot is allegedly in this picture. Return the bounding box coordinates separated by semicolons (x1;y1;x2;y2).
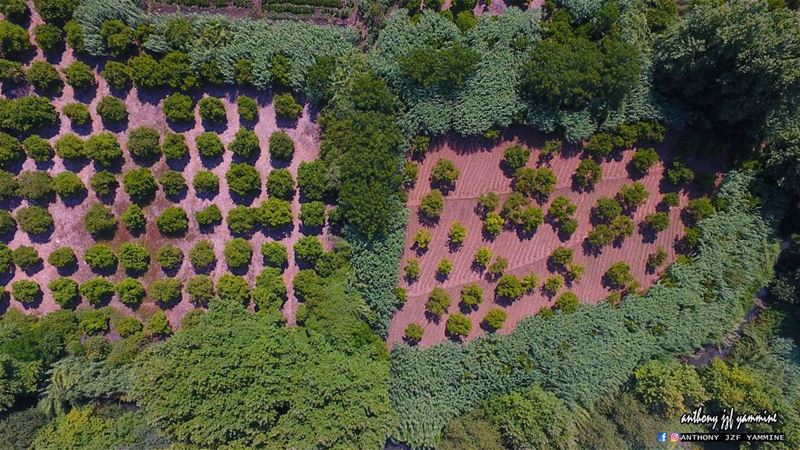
388;130;720;347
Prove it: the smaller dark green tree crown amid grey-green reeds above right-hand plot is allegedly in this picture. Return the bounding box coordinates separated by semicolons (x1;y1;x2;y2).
399;45;480;87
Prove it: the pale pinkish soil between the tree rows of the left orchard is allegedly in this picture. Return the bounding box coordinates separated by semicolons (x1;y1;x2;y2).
3;8;327;326
